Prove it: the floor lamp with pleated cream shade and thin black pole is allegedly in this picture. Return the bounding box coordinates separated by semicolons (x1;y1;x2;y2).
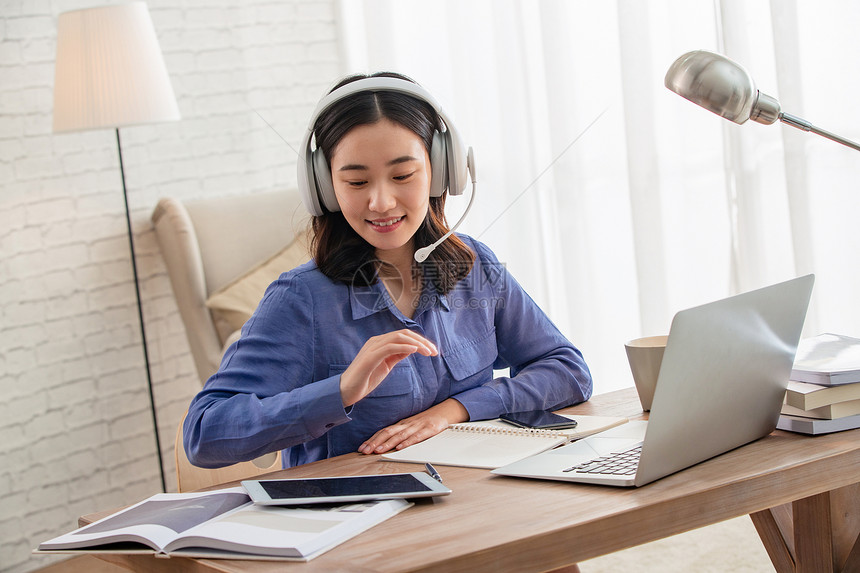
54;2;179;491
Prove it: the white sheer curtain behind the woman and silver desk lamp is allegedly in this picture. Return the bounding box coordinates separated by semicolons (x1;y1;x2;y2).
340;0;860;392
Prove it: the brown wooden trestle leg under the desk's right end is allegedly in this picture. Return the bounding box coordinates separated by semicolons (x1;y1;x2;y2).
750;484;860;573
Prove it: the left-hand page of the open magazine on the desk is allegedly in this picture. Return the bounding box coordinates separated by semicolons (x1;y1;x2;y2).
39;487;251;551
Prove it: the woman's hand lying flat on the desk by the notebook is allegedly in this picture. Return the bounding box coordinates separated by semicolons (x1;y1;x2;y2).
358;398;469;454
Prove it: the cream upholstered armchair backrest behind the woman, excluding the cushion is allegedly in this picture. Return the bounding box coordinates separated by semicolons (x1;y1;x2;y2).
152;190;307;384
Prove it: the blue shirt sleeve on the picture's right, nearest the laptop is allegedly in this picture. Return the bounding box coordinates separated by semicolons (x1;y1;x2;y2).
453;240;593;420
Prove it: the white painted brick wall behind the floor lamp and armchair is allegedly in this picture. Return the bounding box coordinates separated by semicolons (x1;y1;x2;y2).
0;0;341;573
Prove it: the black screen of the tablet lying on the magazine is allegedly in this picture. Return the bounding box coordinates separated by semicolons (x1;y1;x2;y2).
255;474;430;499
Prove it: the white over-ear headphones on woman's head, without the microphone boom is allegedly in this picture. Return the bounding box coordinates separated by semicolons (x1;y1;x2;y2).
298;77;474;217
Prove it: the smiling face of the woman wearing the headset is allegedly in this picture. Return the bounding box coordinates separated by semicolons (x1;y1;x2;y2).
331;119;431;256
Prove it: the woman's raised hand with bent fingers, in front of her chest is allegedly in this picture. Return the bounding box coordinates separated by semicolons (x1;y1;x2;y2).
340;329;439;408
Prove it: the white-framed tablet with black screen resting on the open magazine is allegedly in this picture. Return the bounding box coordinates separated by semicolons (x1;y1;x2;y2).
242;472;451;505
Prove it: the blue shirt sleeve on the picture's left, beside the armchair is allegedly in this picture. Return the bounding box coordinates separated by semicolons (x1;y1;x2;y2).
183;273;350;468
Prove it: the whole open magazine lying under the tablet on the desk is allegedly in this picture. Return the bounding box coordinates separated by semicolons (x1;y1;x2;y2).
37;487;412;561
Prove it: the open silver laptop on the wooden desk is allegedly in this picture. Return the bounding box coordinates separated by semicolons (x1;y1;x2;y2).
493;275;814;486
